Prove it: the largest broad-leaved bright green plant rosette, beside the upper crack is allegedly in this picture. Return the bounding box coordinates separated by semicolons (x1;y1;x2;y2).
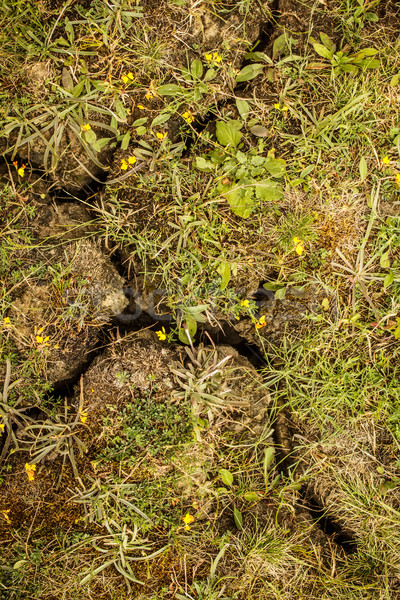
196;119;286;219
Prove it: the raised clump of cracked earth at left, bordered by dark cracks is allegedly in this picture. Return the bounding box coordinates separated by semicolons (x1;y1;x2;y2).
8;239;129;384
